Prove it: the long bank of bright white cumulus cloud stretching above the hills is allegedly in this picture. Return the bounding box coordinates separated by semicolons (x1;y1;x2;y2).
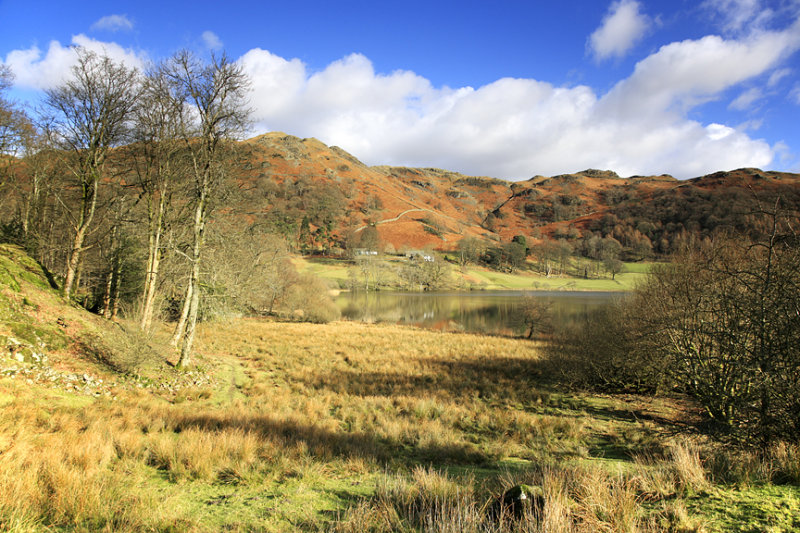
240;28;797;179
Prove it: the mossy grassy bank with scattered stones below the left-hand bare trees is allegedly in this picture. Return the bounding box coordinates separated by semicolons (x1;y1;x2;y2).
0;244;208;398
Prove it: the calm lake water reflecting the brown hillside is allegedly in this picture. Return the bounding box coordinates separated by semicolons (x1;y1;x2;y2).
336;291;619;336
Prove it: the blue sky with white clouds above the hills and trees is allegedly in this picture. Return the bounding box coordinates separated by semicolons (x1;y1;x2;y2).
0;0;800;180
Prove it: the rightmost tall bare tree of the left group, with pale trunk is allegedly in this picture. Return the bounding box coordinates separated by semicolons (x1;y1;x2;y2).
161;51;249;367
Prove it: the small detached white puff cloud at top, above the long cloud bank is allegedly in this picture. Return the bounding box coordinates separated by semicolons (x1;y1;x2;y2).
588;0;651;60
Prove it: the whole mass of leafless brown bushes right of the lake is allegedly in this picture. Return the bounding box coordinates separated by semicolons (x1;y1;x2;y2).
555;213;800;444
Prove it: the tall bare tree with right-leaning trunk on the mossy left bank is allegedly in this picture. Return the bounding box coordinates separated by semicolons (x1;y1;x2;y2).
44;49;139;298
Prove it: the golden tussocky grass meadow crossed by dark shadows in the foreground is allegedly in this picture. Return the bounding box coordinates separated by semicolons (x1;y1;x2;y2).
0;243;800;532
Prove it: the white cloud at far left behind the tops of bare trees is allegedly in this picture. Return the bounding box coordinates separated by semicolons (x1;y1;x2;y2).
4;34;146;89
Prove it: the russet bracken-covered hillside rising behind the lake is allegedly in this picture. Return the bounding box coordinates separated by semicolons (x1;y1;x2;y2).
240;133;800;253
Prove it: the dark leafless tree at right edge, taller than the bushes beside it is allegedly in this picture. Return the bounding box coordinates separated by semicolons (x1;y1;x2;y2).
635;205;800;444
